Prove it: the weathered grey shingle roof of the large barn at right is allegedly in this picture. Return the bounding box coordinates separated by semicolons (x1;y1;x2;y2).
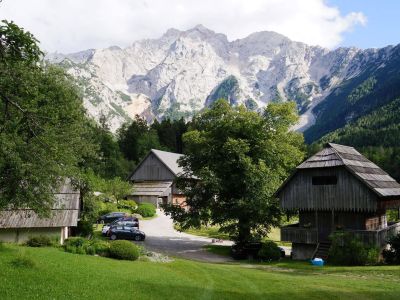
297;143;400;197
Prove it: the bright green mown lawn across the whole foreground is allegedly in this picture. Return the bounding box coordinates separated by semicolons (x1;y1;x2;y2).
0;245;400;300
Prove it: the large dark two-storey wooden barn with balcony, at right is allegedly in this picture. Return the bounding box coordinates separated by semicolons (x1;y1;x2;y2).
276;143;400;259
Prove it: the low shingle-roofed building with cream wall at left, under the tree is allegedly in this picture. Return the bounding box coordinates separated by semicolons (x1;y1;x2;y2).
0;181;80;244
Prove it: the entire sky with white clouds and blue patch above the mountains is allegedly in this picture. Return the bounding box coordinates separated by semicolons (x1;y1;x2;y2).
0;0;400;53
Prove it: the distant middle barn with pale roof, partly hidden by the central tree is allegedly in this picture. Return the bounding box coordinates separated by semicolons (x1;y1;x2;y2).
128;149;185;206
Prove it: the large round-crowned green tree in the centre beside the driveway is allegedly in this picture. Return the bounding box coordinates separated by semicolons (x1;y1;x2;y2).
165;100;304;242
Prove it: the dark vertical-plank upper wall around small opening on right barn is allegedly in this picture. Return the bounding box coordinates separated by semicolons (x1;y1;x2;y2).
278;167;378;211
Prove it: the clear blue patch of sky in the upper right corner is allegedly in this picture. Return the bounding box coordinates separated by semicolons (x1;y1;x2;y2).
327;0;400;48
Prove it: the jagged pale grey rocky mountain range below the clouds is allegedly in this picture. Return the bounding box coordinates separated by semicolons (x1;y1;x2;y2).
46;25;393;133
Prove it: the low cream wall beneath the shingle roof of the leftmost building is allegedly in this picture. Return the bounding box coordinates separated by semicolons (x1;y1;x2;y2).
0;227;61;244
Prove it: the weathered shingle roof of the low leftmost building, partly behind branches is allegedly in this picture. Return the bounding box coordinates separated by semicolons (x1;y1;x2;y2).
0;180;79;228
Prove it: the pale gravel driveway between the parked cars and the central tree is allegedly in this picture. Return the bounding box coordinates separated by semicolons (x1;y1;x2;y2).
140;210;232;263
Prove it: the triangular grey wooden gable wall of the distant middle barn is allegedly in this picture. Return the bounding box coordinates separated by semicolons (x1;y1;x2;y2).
131;153;175;181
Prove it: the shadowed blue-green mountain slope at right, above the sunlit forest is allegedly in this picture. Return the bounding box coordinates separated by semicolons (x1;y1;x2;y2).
304;46;400;146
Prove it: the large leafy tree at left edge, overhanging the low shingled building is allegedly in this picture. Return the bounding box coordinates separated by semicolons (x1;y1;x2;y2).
0;21;94;214
